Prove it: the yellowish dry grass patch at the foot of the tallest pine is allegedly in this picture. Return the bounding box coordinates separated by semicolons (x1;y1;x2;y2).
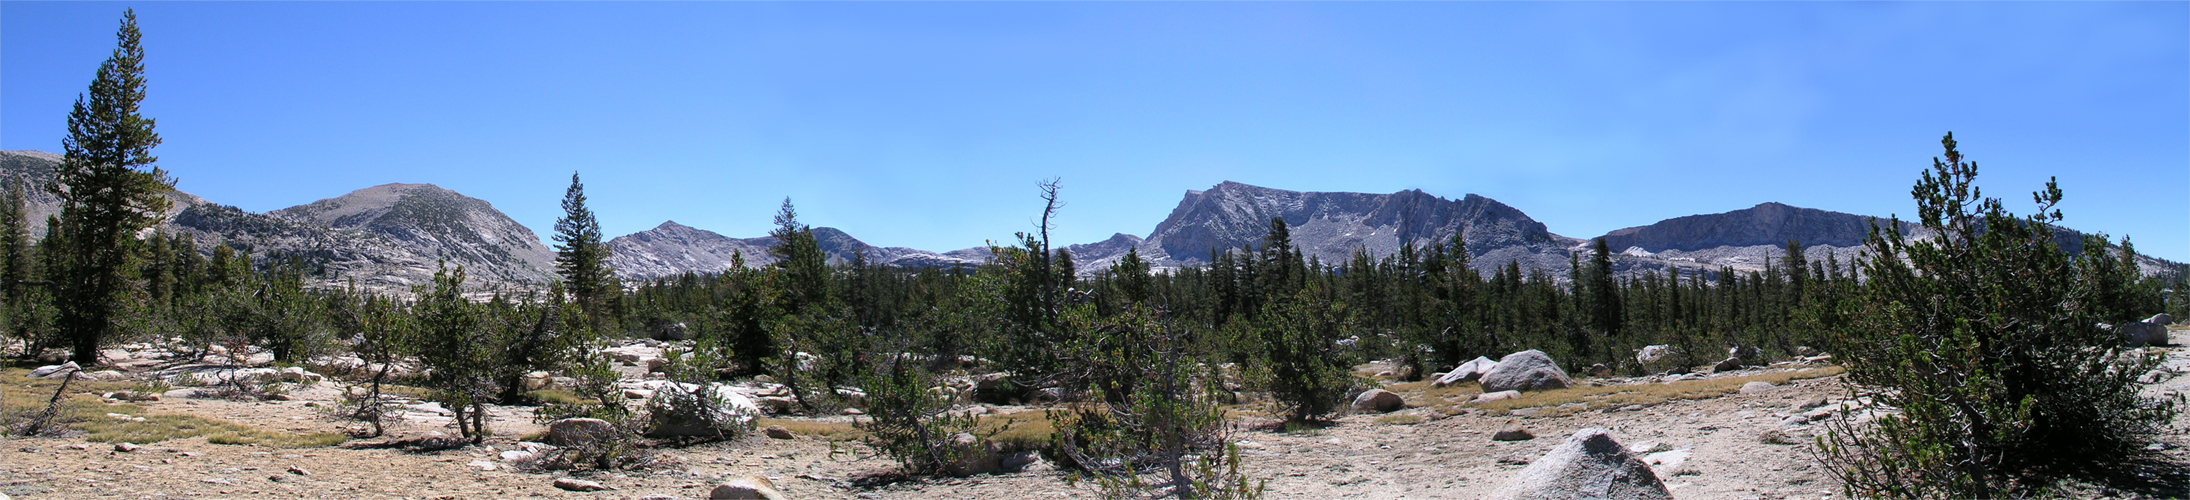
0;368;346;447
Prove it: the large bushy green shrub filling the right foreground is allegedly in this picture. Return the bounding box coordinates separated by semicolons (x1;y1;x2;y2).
1820;134;2179;498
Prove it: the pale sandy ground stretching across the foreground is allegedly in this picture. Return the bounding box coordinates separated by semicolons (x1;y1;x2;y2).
0;331;2190;500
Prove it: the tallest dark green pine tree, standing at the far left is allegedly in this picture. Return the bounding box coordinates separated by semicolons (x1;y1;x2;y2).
46;11;175;364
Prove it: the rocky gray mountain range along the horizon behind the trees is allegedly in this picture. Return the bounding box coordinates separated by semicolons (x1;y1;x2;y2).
0;151;2181;292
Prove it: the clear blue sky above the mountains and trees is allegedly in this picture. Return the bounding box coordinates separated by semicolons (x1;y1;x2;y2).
0;2;2190;261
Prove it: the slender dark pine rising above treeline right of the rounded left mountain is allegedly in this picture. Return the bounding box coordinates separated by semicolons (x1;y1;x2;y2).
554;171;622;336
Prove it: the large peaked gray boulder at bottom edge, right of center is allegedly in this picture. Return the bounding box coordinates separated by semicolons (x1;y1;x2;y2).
1489;430;1673;500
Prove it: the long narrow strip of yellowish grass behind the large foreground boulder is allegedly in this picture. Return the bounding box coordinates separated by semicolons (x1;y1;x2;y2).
1483;366;1842;417
